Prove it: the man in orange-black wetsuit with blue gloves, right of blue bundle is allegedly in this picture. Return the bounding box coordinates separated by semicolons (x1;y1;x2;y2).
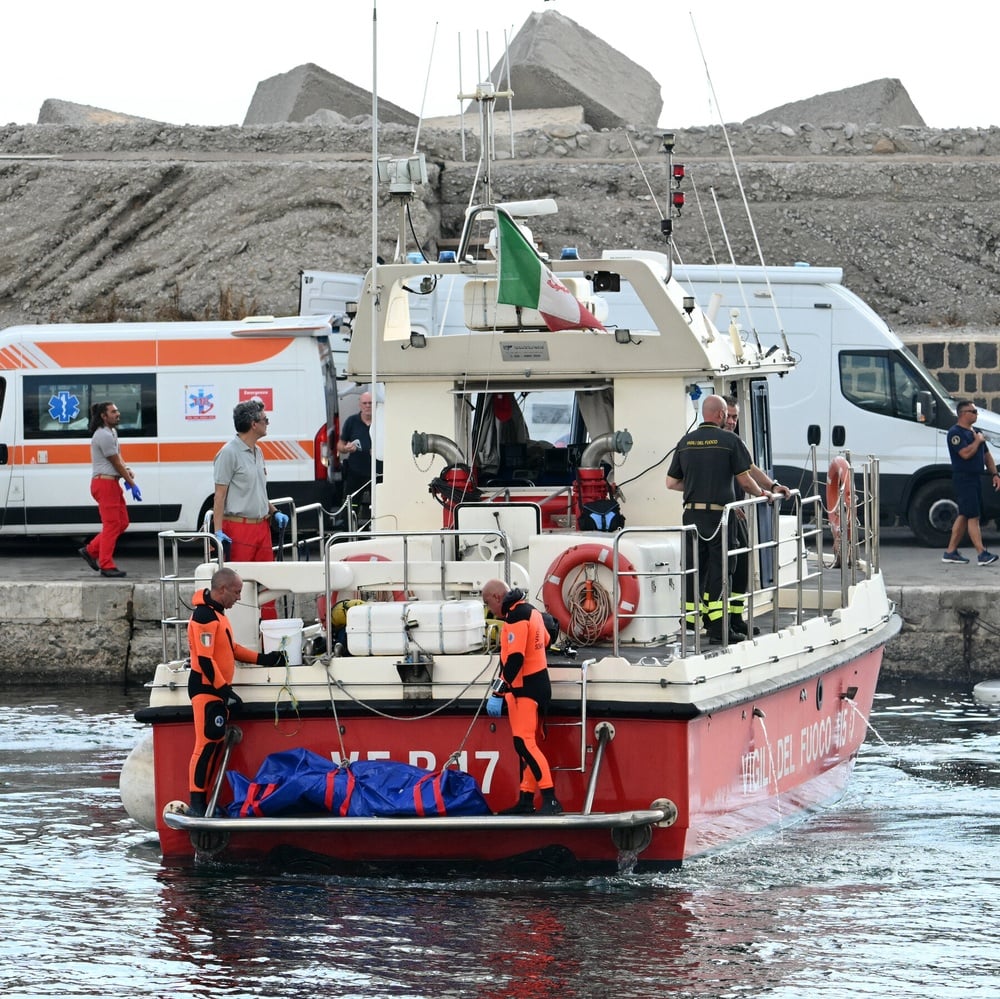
483;579;562;815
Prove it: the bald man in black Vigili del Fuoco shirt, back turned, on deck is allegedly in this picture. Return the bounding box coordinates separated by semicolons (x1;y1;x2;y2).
667;395;771;645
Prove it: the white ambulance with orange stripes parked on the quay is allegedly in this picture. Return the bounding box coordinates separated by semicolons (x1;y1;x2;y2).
0;316;339;535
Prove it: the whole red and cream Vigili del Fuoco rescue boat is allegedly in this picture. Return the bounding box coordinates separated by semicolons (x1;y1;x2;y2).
122;87;900;874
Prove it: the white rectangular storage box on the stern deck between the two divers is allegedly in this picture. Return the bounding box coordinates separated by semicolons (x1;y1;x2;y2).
347;600;484;656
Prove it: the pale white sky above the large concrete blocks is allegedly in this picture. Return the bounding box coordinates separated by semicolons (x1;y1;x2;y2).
0;0;1000;132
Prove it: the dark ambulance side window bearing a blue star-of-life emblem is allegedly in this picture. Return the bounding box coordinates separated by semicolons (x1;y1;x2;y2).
24;373;156;440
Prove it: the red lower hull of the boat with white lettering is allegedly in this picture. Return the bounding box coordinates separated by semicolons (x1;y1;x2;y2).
148;647;882;870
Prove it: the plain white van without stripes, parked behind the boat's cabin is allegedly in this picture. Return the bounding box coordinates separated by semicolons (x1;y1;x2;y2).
300;260;1000;546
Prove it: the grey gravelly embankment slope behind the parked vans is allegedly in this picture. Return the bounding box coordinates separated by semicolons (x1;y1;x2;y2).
0;119;1000;336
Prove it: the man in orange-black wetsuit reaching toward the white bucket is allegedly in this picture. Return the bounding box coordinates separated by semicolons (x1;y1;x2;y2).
188;569;284;815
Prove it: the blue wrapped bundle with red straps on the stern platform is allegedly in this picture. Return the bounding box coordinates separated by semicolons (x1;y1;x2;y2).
226;749;490;818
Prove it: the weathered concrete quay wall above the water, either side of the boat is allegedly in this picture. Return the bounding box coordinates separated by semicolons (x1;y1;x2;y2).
0;580;1000;686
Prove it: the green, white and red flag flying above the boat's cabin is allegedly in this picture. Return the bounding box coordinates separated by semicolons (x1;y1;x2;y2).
497;211;604;333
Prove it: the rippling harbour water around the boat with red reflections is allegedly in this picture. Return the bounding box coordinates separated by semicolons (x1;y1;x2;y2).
0;685;1000;999
